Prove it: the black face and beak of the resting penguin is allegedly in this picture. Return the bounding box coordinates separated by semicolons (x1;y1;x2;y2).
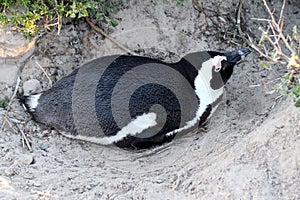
209;48;251;84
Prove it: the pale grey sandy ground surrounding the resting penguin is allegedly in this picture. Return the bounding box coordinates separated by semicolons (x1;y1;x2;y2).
0;0;300;199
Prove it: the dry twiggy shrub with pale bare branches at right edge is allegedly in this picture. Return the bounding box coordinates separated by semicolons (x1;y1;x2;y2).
250;0;300;107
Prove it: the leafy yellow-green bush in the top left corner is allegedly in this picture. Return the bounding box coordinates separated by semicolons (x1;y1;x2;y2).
0;0;124;38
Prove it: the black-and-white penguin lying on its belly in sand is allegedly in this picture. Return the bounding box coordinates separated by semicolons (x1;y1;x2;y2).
22;48;251;149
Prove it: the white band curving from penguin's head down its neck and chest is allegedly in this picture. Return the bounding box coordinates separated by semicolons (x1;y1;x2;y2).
167;56;226;136
